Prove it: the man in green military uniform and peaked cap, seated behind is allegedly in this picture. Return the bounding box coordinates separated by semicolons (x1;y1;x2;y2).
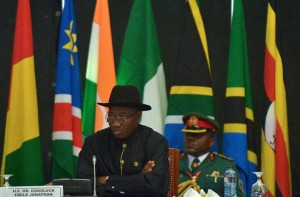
178;113;245;196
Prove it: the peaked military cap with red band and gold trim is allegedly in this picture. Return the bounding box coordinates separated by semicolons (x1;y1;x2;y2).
182;112;220;133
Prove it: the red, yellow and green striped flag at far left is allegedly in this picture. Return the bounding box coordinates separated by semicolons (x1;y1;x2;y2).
1;0;44;186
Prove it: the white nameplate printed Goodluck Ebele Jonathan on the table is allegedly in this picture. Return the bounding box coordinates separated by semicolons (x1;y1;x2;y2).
4;185;64;197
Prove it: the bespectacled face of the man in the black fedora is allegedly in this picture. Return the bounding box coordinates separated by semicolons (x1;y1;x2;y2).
107;106;142;139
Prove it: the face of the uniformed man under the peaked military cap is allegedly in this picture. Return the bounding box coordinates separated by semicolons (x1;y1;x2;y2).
184;132;214;157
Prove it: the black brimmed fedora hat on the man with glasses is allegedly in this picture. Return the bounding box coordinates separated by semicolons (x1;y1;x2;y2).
98;85;151;111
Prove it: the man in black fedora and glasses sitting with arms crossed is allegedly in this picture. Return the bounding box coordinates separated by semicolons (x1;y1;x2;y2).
77;85;169;197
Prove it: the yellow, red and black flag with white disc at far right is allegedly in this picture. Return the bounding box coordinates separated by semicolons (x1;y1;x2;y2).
261;0;292;197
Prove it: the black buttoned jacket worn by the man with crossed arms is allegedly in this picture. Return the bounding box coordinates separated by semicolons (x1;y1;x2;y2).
77;125;169;197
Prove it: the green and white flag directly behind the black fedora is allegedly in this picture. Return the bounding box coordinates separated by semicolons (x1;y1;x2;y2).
117;0;167;133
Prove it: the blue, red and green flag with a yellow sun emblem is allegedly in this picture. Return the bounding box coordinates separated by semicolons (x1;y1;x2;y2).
52;0;82;179
